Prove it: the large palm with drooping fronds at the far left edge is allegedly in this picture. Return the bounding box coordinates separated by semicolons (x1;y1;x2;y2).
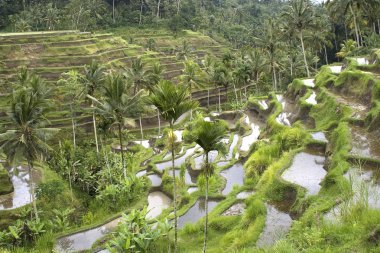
0;72;58;219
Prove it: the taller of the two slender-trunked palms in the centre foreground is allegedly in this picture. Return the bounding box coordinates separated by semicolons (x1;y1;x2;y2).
148;80;199;252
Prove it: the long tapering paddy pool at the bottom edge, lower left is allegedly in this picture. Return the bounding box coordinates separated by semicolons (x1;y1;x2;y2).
56;217;121;253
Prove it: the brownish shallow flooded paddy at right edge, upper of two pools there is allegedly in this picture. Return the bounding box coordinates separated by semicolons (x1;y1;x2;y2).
350;126;380;159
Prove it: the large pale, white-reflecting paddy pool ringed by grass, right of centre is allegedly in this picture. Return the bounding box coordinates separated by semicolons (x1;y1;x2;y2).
281;152;327;195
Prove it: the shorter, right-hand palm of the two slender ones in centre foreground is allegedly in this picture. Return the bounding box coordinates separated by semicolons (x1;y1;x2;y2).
189;119;228;252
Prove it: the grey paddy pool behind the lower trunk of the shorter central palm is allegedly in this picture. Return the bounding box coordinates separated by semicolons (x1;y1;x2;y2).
178;199;219;228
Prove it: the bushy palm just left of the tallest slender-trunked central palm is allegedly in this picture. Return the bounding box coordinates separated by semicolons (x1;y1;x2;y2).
88;73;144;178
